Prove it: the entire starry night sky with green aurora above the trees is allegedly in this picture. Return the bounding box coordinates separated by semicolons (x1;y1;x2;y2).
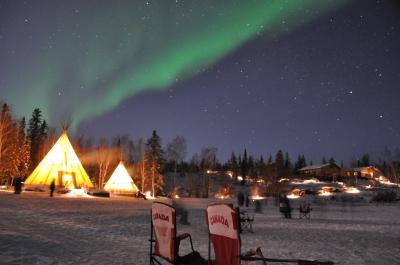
0;0;400;163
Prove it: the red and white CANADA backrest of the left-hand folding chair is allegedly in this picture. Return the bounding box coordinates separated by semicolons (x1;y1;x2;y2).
151;202;176;262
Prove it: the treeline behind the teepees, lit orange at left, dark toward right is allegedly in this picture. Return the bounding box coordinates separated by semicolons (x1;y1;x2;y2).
0;103;400;194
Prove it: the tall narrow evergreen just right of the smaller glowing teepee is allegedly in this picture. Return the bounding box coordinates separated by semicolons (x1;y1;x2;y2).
146;130;164;196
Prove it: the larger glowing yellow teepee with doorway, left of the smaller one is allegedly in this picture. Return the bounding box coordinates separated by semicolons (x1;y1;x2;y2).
25;131;93;188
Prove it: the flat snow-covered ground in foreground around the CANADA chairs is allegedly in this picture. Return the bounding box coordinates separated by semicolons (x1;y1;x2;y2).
0;192;400;264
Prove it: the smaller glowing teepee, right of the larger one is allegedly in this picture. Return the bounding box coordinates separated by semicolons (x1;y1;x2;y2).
104;162;139;193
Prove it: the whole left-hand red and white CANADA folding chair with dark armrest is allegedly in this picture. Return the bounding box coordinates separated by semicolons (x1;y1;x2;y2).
150;202;207;265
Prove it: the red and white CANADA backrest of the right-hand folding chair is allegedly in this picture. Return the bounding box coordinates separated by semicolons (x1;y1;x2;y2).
206;204;240;265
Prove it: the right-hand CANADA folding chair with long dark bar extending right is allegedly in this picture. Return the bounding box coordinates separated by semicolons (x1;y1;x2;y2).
206;204;334;265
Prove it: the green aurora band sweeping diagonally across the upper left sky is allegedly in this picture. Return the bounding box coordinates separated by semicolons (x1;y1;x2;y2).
0;0;343;129
